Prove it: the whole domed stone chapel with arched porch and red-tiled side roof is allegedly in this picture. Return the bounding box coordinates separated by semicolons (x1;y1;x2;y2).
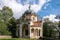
16;6;43;39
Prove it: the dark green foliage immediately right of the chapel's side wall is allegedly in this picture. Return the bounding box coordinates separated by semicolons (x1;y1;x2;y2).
43;21;55;37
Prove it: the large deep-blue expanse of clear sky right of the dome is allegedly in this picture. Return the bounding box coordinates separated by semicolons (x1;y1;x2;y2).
38;0;60;16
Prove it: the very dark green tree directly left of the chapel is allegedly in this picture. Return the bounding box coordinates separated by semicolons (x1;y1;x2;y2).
7;17;16;37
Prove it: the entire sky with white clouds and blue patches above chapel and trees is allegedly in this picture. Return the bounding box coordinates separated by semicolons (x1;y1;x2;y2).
0;0;60;21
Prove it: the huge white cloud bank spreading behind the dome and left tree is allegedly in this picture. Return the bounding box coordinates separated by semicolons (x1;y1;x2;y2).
0;0;48;19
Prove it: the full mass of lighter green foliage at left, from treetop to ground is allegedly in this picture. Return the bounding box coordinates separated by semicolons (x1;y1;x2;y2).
0;6;13;35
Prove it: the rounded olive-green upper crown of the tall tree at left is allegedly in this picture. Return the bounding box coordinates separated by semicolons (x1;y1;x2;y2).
2;6;13;23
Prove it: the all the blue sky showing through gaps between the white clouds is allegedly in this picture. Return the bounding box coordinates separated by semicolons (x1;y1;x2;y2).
16;0;60;17
